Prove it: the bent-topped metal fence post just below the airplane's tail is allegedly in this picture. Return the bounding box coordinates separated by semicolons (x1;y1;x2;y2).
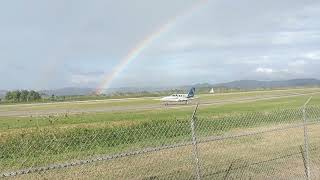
191;103;201;180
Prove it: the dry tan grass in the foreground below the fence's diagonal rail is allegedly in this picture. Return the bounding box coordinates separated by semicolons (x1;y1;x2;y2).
13;126;320;179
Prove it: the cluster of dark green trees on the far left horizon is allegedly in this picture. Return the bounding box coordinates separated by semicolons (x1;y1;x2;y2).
5;90;42;102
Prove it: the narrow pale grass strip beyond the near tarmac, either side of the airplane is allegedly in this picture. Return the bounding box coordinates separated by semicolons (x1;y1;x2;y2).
0;88;320;113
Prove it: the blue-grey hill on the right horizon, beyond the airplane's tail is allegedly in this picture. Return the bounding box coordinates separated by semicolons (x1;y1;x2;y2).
212;79;320;89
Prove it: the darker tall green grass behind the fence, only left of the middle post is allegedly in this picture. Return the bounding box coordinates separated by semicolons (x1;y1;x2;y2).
0;120;191;170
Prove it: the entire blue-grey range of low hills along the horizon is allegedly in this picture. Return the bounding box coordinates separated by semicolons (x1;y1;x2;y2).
11;79;320;97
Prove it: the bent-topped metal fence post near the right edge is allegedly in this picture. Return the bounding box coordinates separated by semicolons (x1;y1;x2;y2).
302;96;312;180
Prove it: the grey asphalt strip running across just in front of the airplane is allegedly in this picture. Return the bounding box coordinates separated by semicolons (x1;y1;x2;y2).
0;92;320;118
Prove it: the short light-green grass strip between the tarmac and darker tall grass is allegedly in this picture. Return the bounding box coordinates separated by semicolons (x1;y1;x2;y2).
0;93;320;134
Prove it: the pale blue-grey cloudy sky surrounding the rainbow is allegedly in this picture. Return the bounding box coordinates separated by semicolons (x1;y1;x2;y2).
0;0;320;89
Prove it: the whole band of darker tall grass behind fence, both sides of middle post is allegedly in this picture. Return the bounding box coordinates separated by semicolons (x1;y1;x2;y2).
0;108;320;171
